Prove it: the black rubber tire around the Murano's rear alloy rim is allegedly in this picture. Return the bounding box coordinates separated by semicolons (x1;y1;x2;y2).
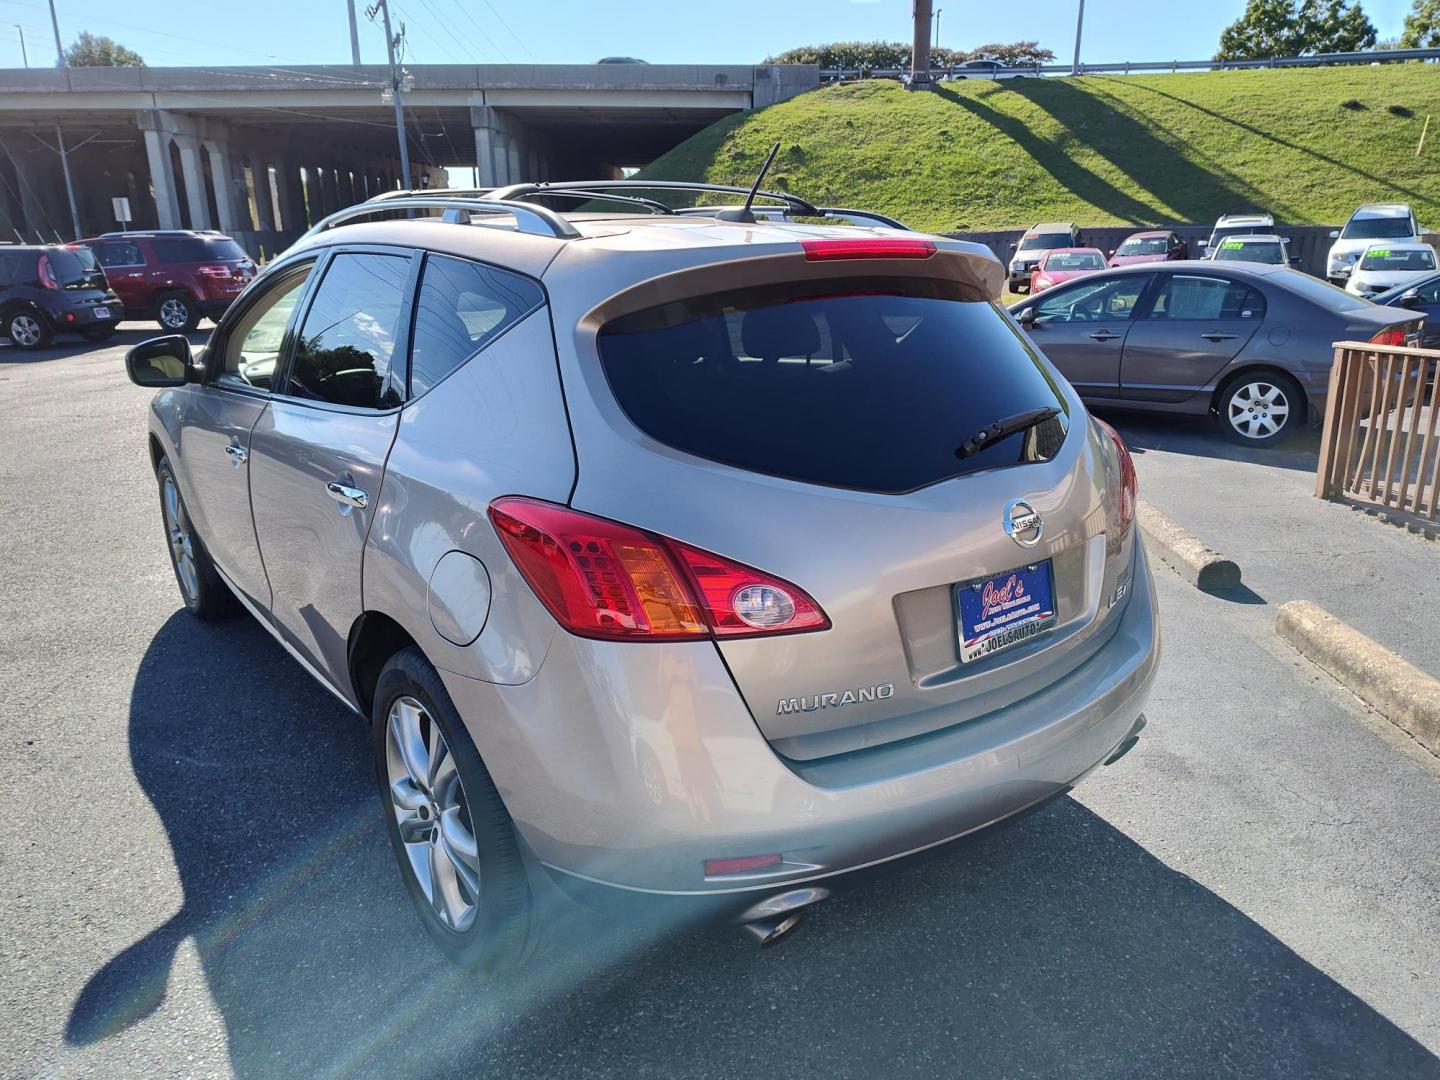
370;647;534;975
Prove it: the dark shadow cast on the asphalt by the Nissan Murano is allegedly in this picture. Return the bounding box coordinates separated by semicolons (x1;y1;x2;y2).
66;612;1440;1079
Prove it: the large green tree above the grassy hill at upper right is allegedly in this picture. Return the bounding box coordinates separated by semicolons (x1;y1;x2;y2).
1215;0;1378;60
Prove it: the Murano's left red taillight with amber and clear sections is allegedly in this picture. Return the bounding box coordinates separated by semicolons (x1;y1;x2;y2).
490;495;829;641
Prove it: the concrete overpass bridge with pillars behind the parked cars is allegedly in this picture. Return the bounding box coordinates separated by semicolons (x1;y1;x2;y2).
0;63;819;255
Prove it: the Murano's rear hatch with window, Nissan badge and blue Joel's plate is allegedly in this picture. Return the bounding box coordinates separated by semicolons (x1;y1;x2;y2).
555;240;1133;759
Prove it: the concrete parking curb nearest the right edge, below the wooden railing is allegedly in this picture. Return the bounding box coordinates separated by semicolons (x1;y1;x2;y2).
1274;600;1440;756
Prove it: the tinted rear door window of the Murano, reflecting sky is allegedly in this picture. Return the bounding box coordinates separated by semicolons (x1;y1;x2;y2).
285;255;410;409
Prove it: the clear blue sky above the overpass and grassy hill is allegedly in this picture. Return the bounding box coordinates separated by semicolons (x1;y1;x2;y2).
0;0;1410;68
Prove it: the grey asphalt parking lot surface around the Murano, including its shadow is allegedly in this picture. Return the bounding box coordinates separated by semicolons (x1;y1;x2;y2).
8;328;1440;1077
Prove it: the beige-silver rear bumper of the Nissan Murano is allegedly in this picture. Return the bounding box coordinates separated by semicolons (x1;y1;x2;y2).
442;547;1159;910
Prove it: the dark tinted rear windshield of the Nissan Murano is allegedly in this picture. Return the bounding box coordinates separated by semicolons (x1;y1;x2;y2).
599;278;1067;492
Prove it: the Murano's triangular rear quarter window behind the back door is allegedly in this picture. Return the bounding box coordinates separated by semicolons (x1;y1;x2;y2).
410;255;544;395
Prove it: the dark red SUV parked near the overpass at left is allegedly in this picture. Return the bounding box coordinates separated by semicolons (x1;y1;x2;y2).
81;229;256;333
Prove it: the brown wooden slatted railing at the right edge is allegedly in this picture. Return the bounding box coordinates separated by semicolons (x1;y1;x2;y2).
1315;341;1440;524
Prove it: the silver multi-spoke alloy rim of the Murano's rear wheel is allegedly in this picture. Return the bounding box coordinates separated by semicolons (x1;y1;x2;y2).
384;697;481;932
